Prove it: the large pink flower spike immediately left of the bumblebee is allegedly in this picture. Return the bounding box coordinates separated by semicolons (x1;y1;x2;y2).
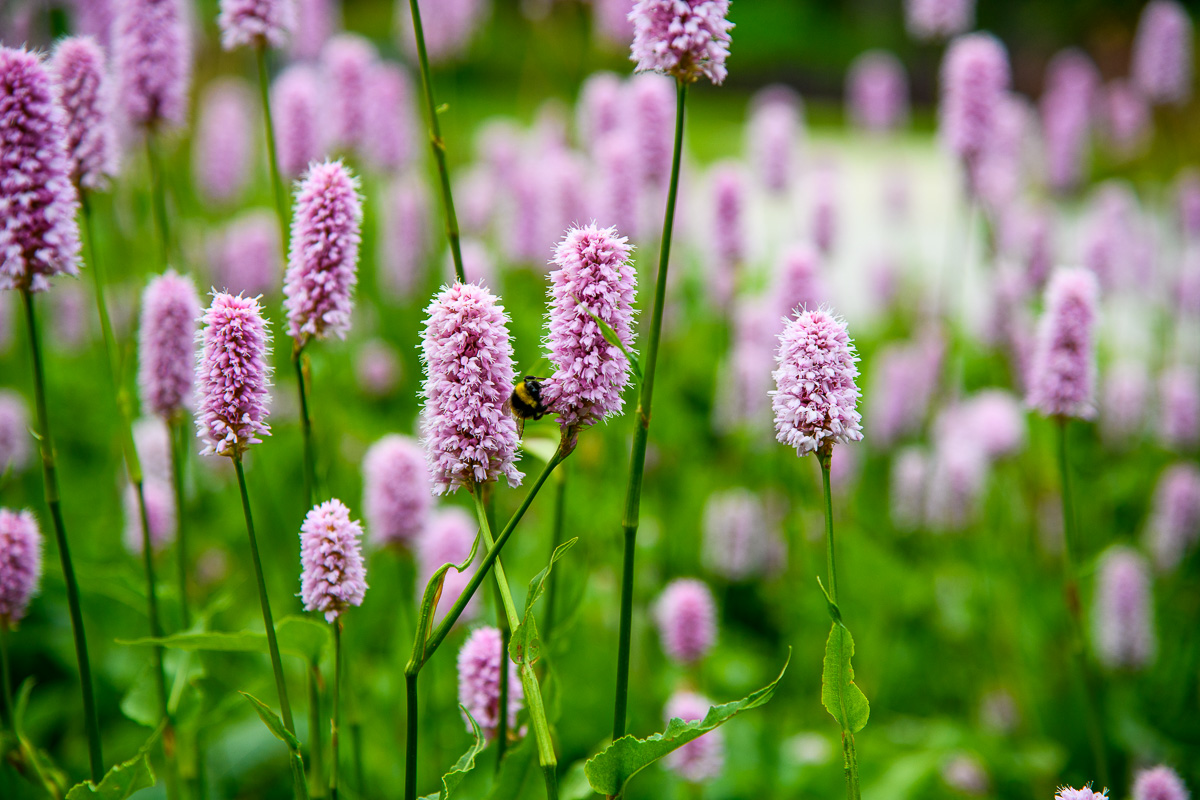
421;283;522;494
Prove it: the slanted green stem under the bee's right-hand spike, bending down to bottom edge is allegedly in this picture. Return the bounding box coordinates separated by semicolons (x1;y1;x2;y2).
404;445;566;800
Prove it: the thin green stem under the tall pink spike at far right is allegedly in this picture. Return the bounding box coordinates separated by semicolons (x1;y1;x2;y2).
1056;417;1109;786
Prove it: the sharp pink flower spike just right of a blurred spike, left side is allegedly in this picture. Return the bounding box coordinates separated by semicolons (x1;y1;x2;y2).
196;293;271;458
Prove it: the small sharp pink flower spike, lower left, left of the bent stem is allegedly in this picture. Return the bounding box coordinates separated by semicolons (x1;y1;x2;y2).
300;499;367;622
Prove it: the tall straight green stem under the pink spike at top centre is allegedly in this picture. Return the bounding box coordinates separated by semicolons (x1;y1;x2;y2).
612;79;688;741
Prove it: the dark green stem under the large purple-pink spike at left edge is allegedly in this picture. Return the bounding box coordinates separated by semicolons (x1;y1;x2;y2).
20;289;104;784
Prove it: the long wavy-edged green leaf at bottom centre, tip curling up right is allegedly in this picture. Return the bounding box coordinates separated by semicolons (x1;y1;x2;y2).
583;649;792;796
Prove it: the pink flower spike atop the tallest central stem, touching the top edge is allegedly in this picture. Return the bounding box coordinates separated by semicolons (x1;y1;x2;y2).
629;0;733;85
